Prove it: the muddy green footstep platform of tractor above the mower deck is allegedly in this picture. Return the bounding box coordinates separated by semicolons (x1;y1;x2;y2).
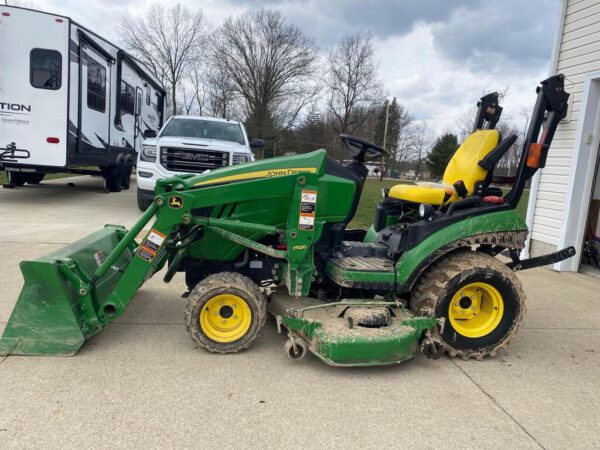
326;256;396;291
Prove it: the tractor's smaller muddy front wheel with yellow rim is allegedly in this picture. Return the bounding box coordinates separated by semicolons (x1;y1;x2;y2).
185;272;267;353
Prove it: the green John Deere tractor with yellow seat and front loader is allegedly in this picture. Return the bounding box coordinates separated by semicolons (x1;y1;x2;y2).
0;75;574;366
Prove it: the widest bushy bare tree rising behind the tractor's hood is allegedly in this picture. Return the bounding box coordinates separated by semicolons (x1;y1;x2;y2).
209;9;316;156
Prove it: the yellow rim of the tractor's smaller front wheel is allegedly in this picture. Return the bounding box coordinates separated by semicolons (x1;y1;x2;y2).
199;294;252;343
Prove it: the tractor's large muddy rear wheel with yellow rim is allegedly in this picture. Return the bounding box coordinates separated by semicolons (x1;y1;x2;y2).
410;250;525;359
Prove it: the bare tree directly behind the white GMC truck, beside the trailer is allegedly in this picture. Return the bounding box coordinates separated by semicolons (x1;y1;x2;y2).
117;3;205;114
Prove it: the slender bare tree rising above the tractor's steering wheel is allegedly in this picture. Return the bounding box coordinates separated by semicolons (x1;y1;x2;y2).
326;31;379;133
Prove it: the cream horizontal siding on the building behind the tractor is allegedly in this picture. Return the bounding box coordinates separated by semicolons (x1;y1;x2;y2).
530;0;600;256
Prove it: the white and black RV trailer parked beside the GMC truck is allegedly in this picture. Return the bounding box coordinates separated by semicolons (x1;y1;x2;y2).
0;5;165;192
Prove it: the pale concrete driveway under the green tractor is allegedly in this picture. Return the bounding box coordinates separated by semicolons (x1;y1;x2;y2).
0;177;600;449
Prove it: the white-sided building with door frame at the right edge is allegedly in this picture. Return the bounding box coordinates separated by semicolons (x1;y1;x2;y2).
525;0;600;271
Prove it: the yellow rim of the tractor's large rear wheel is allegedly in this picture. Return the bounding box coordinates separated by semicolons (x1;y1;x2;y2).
448;282;504;338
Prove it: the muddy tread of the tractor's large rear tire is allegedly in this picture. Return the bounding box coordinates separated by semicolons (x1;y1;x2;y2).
410;249;526;360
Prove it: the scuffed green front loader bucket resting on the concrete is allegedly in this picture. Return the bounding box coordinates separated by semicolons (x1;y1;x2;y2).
0;225;132;356
